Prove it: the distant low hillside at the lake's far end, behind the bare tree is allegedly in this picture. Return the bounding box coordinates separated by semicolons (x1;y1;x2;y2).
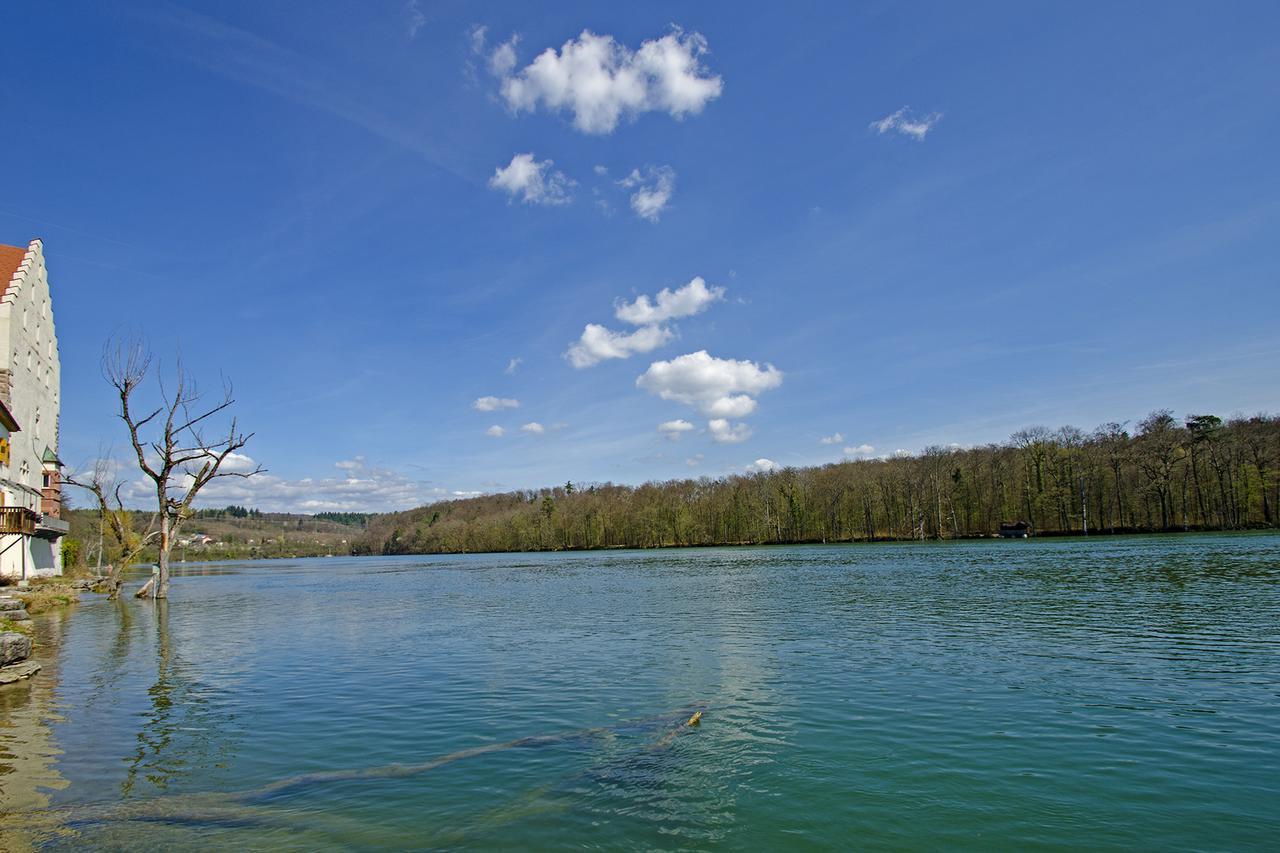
65;506;372;565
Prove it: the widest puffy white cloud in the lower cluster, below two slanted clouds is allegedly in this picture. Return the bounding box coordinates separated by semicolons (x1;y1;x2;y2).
636;350;782;419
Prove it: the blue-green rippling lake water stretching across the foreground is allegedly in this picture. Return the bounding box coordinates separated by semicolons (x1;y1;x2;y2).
0;535;1280;850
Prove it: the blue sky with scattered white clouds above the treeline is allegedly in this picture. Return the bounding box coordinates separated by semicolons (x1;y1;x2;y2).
0;0;1280;512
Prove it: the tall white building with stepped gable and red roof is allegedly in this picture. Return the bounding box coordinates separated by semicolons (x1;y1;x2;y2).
0;240;69;578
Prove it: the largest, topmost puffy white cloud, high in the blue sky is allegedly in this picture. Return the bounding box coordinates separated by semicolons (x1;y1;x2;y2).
489;28;723;133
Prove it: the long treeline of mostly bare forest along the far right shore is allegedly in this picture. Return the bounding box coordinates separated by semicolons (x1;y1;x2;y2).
355;410;1280;555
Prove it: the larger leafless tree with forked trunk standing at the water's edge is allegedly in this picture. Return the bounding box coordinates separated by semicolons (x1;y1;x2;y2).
99;339;264;598
